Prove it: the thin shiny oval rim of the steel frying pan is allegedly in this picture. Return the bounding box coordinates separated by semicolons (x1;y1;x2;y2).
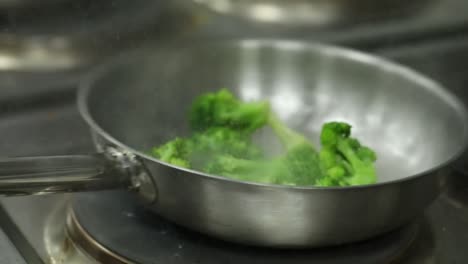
77;38;468;191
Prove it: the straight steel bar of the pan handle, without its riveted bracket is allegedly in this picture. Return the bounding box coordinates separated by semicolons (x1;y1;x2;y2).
0;154;130;196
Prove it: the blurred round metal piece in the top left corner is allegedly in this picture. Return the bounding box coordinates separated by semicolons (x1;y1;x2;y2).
0;0;196;105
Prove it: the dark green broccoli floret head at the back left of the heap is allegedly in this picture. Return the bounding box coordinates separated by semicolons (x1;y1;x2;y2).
189;89;270;133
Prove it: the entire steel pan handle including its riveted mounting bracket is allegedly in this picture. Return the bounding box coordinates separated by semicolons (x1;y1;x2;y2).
0;148;156;202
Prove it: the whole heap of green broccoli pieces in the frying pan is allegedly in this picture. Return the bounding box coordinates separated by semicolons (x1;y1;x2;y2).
151;89;377;186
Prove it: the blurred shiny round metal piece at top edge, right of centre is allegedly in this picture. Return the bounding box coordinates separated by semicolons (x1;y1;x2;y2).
182;0;433;26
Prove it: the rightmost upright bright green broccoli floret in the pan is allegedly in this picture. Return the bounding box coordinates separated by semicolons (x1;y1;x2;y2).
318;122;377;186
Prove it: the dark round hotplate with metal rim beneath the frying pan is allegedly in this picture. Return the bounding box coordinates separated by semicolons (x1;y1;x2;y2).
67;191;418;264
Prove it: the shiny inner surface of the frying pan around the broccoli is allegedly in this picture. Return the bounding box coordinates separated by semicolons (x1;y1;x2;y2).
84;41;466;182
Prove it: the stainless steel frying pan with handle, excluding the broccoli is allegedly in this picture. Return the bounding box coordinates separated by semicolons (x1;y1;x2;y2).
0;40;468;247
